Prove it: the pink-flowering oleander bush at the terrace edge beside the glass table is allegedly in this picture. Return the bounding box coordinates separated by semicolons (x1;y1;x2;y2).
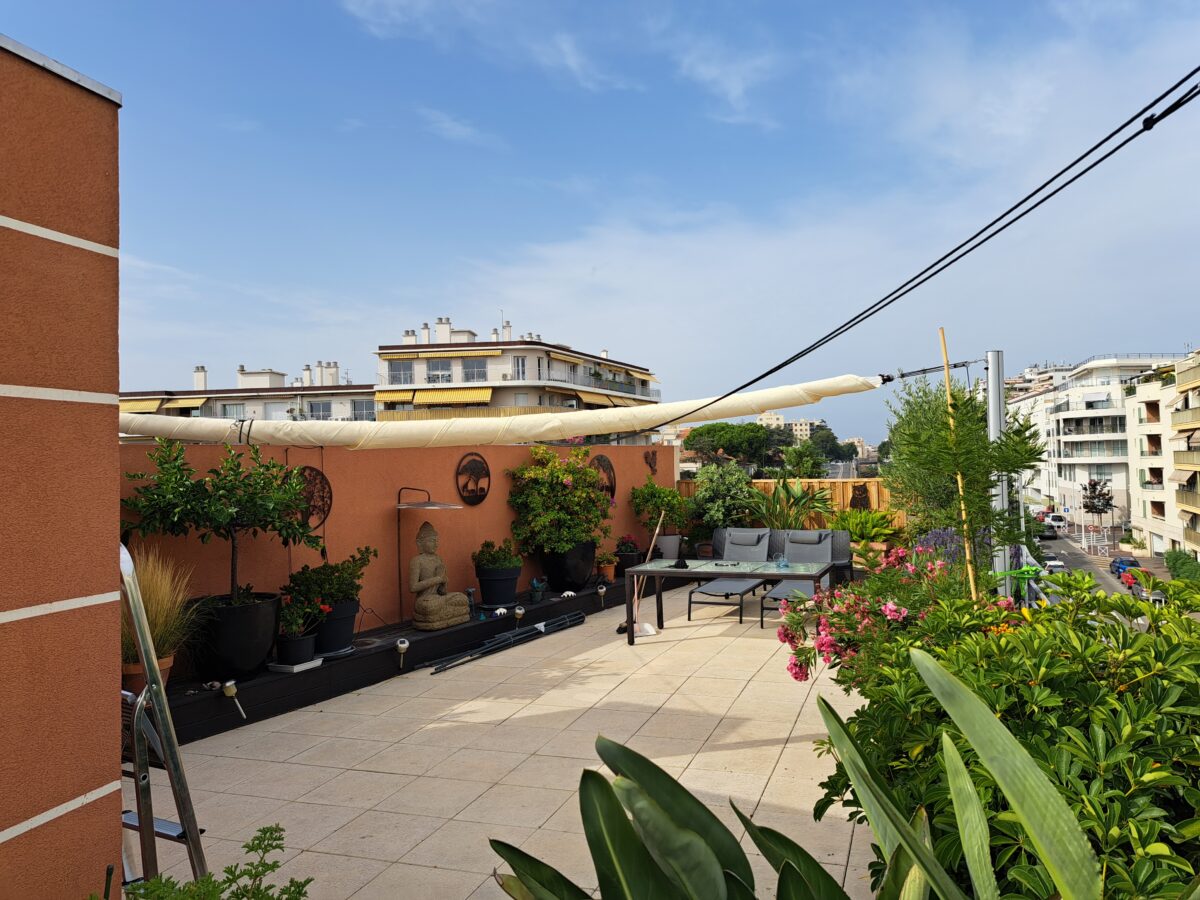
778;545;1019;690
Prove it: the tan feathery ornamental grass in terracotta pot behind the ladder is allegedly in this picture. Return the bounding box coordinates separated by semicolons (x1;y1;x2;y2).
121;547;199;694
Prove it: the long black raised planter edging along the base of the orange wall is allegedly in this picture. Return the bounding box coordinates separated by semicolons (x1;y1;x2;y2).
167;581;633;744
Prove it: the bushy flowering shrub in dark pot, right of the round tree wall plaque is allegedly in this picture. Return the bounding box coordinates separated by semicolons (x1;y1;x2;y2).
508;446;613;590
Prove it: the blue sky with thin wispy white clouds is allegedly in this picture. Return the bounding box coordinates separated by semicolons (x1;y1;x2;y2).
0;0;1200;439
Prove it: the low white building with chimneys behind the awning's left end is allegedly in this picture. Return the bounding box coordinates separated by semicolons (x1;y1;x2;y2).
120;360;376;421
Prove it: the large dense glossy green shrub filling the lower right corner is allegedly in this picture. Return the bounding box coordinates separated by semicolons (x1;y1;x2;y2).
796;569;1200;898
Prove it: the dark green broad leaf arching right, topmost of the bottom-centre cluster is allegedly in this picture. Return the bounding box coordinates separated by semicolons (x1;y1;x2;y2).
596;737;754;890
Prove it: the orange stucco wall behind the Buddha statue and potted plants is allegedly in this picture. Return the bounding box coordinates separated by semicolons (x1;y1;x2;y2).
121;444;674;626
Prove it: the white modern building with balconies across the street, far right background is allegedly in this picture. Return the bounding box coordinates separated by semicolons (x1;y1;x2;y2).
1008;353;1184;521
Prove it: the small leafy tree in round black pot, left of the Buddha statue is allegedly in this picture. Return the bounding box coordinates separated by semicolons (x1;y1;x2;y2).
124;438;320;678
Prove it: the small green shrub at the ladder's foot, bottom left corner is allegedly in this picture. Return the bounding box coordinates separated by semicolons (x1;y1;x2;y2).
118;824;312;900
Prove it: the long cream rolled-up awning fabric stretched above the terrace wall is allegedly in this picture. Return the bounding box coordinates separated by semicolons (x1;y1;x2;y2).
120;374;881;450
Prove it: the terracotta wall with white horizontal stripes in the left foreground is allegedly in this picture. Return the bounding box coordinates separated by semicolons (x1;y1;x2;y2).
0;36;121;900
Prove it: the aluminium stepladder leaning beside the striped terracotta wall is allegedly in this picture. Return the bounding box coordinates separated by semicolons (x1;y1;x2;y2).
121;545;208;884
